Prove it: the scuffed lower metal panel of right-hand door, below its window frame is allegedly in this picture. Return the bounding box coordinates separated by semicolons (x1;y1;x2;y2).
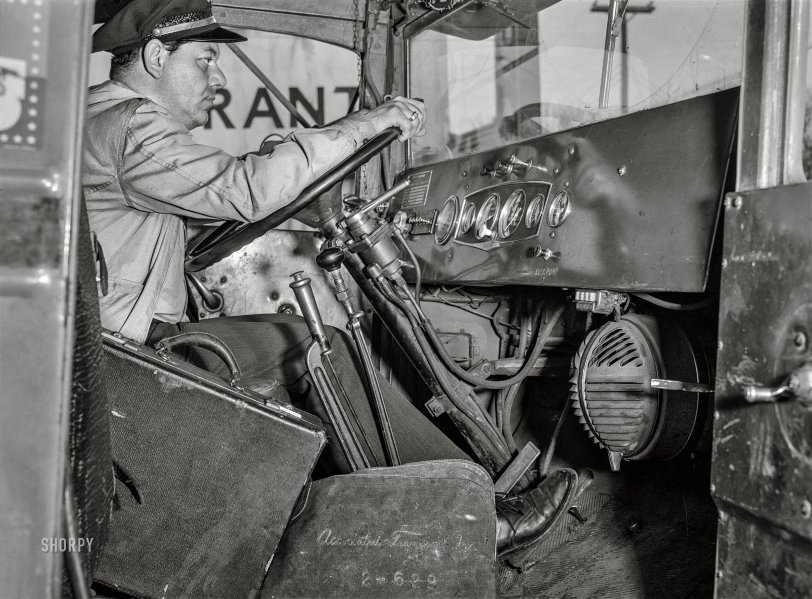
711;184;812;598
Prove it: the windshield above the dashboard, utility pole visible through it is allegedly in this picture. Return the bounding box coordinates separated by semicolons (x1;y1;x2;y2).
409;0;744;166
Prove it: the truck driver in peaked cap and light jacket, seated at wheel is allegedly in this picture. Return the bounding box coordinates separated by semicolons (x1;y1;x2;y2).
83;0;577;564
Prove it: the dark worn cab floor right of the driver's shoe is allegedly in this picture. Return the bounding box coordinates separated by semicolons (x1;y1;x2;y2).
500;460;716;599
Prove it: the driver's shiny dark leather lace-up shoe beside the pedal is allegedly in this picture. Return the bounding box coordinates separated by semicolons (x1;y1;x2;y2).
496;468;578;558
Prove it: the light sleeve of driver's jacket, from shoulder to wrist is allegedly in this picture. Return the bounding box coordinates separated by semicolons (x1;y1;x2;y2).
119;101;375;222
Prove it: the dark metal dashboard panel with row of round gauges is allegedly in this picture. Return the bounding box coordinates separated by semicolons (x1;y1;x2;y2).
390;89;738;292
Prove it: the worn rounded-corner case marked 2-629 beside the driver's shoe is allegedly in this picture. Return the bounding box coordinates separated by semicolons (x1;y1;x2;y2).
262;460;496;599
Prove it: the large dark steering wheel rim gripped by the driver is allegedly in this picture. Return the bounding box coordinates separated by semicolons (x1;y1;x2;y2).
186;127;400;272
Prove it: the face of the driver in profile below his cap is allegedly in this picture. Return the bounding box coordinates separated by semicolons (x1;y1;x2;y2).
158;42;227;129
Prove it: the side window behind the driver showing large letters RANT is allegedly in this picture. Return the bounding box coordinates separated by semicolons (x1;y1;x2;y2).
91;28;358;155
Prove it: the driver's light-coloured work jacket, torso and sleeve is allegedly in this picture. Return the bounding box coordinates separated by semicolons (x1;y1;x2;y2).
82;81;375;341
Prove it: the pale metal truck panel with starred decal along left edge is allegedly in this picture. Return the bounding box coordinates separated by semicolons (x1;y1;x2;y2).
0;0;93;599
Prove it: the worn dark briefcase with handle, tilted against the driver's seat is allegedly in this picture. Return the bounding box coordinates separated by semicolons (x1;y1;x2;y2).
95;333;326;599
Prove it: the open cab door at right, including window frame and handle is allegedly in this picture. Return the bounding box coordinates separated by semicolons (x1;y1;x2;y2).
711;0;812;598
